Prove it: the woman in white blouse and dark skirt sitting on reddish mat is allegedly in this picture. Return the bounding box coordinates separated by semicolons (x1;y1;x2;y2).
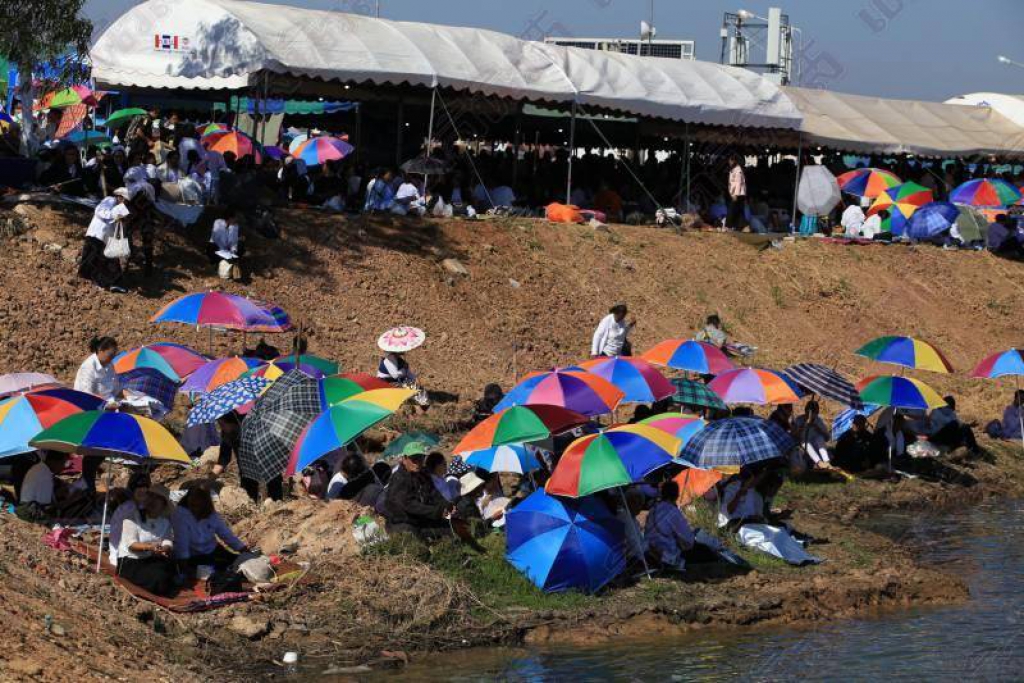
118;485;177;598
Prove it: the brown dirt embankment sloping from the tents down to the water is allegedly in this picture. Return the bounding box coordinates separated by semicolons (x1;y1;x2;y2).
0;204;1024;680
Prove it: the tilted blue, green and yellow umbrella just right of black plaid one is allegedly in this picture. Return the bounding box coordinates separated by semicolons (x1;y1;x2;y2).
285;389;416;476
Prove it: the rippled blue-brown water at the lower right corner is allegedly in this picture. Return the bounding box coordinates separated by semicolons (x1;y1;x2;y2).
380;501;1024;683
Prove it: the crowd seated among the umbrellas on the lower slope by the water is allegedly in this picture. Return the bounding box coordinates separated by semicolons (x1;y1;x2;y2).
0;294;1024;596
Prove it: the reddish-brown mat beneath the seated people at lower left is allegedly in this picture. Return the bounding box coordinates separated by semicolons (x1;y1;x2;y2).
67;540;308;614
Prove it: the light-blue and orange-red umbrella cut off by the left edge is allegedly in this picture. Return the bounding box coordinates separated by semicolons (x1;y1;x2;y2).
0;388;103;459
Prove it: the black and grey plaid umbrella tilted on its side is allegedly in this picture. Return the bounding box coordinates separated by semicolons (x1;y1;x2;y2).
239;371;324;482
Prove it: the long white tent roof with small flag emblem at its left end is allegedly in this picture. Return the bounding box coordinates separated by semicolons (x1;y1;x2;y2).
92;0;801;130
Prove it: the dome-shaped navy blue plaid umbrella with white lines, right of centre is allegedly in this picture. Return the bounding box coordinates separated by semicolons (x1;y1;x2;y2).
679;418;796;469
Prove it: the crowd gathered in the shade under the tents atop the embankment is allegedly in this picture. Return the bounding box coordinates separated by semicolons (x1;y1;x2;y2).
6;103;1024;291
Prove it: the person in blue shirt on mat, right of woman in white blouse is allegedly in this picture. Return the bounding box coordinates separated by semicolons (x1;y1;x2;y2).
171;486;249;574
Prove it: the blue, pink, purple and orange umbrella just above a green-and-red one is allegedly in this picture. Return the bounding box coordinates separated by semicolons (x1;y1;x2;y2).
495;370;626;417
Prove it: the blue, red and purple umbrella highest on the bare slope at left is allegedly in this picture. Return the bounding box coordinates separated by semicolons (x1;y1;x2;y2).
151;292;292;333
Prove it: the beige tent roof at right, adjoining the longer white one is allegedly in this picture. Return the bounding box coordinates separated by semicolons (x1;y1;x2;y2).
783;87;1024;157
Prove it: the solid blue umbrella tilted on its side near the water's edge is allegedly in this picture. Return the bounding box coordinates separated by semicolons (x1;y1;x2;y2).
506;490;626;593
